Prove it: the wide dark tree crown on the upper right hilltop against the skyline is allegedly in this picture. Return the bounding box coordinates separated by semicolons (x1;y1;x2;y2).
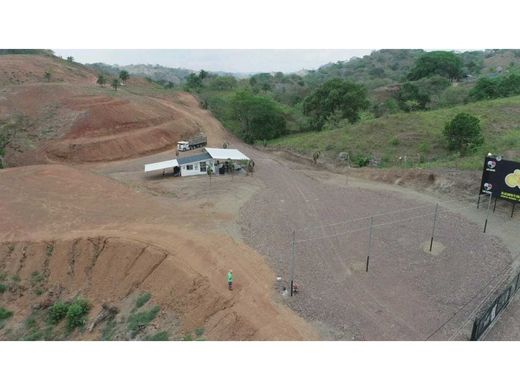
408;51;464;80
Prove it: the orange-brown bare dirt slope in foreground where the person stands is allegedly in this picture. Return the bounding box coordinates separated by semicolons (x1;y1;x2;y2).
0;165;316;340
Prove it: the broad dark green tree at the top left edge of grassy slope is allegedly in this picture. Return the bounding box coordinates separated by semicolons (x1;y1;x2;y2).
303;79;369;130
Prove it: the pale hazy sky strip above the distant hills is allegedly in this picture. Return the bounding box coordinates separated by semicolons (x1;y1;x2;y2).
54;49;372;73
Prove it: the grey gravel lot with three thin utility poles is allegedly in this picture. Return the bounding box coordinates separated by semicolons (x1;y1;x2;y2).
239;149;511;340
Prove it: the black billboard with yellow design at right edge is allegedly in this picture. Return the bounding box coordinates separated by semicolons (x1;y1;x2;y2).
480;156;520;203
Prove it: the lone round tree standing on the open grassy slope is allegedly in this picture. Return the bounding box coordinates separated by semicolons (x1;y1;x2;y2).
444;113;484;155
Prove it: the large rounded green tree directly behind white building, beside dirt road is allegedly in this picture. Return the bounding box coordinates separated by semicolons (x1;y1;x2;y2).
231;90;287;143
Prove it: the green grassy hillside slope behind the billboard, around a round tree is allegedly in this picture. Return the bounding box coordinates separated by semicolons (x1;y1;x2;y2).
269;96;520;169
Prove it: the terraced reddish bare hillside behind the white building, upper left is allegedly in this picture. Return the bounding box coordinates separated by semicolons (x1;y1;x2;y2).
0;55;220;166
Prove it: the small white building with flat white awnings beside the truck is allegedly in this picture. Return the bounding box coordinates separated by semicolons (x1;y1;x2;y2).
144;148;250;176
